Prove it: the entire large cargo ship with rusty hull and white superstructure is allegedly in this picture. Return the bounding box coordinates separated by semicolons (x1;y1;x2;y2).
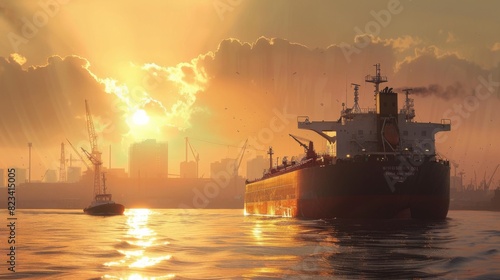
244;64;451;219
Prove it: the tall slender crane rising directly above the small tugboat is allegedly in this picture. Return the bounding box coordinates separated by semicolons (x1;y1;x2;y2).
82;100;102;197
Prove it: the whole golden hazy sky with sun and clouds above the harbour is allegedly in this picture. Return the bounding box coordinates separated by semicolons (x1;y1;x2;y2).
0;0;500;186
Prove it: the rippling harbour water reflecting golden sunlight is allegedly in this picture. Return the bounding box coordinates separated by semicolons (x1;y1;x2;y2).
0;209;500;279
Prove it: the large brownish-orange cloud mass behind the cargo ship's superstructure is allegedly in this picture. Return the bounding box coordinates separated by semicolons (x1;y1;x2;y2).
188;36;500;182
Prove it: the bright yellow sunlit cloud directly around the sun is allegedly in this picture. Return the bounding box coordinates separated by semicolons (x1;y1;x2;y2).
99;58;207;137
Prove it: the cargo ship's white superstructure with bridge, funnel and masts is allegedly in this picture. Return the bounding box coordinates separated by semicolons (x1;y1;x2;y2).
297;64;451;159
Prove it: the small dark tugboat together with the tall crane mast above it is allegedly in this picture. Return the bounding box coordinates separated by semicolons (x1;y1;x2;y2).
81;100;125;216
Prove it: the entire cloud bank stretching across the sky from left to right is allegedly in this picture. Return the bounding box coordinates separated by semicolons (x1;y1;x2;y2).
0;36;500;177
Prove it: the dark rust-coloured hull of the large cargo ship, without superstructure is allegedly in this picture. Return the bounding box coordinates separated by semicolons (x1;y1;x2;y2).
245;160;450;219
